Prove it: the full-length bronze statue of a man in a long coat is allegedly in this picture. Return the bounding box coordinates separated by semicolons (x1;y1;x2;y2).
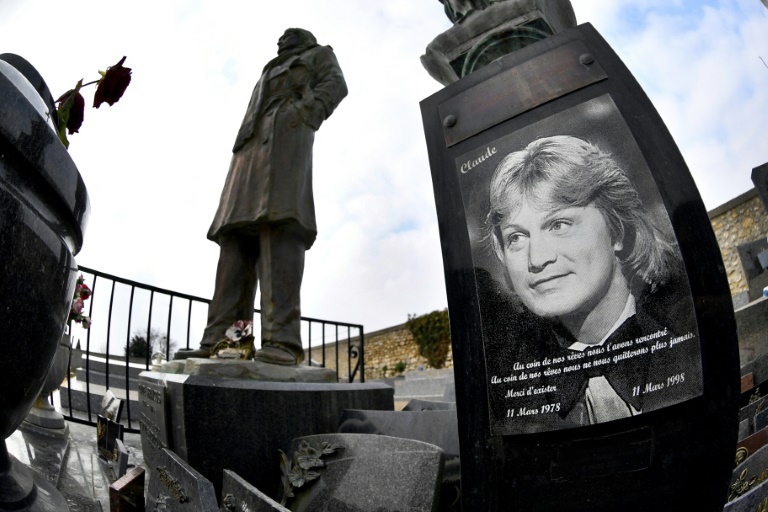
176;28;347;365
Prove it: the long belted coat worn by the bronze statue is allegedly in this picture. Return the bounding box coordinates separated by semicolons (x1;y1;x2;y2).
208;46;347;249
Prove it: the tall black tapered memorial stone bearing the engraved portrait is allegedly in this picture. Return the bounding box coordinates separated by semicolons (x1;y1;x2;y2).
422;24;740;511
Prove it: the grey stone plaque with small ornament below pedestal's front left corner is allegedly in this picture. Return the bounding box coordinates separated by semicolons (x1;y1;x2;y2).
147;448;219;512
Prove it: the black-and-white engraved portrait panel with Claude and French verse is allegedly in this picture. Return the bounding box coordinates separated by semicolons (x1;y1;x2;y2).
456;94;703;435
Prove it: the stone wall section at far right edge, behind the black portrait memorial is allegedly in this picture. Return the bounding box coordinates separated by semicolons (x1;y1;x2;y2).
709;189;768;295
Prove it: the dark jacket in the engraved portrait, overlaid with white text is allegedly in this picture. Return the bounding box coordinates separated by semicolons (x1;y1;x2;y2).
481;272;701;433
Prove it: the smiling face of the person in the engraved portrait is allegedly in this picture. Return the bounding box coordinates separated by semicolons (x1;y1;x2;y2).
493;190;626;319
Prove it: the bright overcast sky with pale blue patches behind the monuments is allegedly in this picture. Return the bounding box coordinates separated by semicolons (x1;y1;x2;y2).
0;0;768;342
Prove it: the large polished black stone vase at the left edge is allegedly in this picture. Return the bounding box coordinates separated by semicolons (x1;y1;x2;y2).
0;54;90;511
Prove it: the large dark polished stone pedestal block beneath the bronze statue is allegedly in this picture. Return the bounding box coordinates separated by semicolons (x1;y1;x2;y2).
139;370;394;498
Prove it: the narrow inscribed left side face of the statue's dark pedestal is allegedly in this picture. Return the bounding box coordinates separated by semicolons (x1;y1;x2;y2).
139;380;173;465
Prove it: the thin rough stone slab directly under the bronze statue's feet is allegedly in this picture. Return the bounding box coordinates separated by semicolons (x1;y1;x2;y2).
160;358;338;382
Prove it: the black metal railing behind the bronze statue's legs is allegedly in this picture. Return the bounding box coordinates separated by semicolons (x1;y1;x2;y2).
60;266;365;432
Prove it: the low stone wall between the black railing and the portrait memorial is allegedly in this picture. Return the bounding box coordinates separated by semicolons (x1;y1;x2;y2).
305;324;453;380
